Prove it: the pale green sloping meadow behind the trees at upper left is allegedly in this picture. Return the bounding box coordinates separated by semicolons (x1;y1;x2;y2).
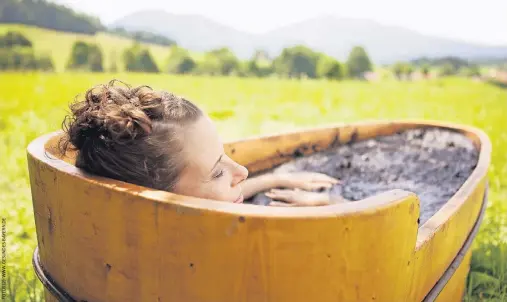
0;24;175;72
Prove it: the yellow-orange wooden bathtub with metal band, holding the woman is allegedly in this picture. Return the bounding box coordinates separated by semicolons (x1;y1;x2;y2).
28;121;491;302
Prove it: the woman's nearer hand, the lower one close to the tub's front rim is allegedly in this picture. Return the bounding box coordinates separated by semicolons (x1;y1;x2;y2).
265;189;330;207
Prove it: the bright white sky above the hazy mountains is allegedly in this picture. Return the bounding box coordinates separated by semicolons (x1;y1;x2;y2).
51;0;507;45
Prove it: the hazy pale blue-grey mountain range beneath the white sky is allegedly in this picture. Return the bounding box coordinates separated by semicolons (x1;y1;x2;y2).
111;11;507;63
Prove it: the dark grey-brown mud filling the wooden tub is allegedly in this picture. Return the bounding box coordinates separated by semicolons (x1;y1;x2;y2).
247;128;479;224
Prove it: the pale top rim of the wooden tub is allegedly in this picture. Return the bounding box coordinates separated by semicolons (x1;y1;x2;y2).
27;119;491;231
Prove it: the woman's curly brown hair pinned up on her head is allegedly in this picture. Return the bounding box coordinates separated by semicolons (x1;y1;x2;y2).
60;80;202;191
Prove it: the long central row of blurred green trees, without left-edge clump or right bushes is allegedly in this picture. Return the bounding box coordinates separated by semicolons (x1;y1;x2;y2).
63;41;372;80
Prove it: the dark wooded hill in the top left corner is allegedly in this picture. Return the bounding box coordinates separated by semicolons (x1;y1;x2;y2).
0;0;104;34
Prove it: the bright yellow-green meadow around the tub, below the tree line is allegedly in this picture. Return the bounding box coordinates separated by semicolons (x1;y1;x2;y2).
0;72;507;301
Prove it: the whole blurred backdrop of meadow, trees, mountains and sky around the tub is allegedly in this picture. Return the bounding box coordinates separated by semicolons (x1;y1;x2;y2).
0;0;507;301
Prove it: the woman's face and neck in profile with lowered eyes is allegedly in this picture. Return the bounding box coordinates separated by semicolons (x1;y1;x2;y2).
173;115;248;203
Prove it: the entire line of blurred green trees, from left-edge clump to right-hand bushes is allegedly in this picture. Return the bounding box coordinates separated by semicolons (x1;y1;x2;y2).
0;31;490;80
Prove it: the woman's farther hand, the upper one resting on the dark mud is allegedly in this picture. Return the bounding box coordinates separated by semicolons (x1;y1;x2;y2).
275;172;340;191
